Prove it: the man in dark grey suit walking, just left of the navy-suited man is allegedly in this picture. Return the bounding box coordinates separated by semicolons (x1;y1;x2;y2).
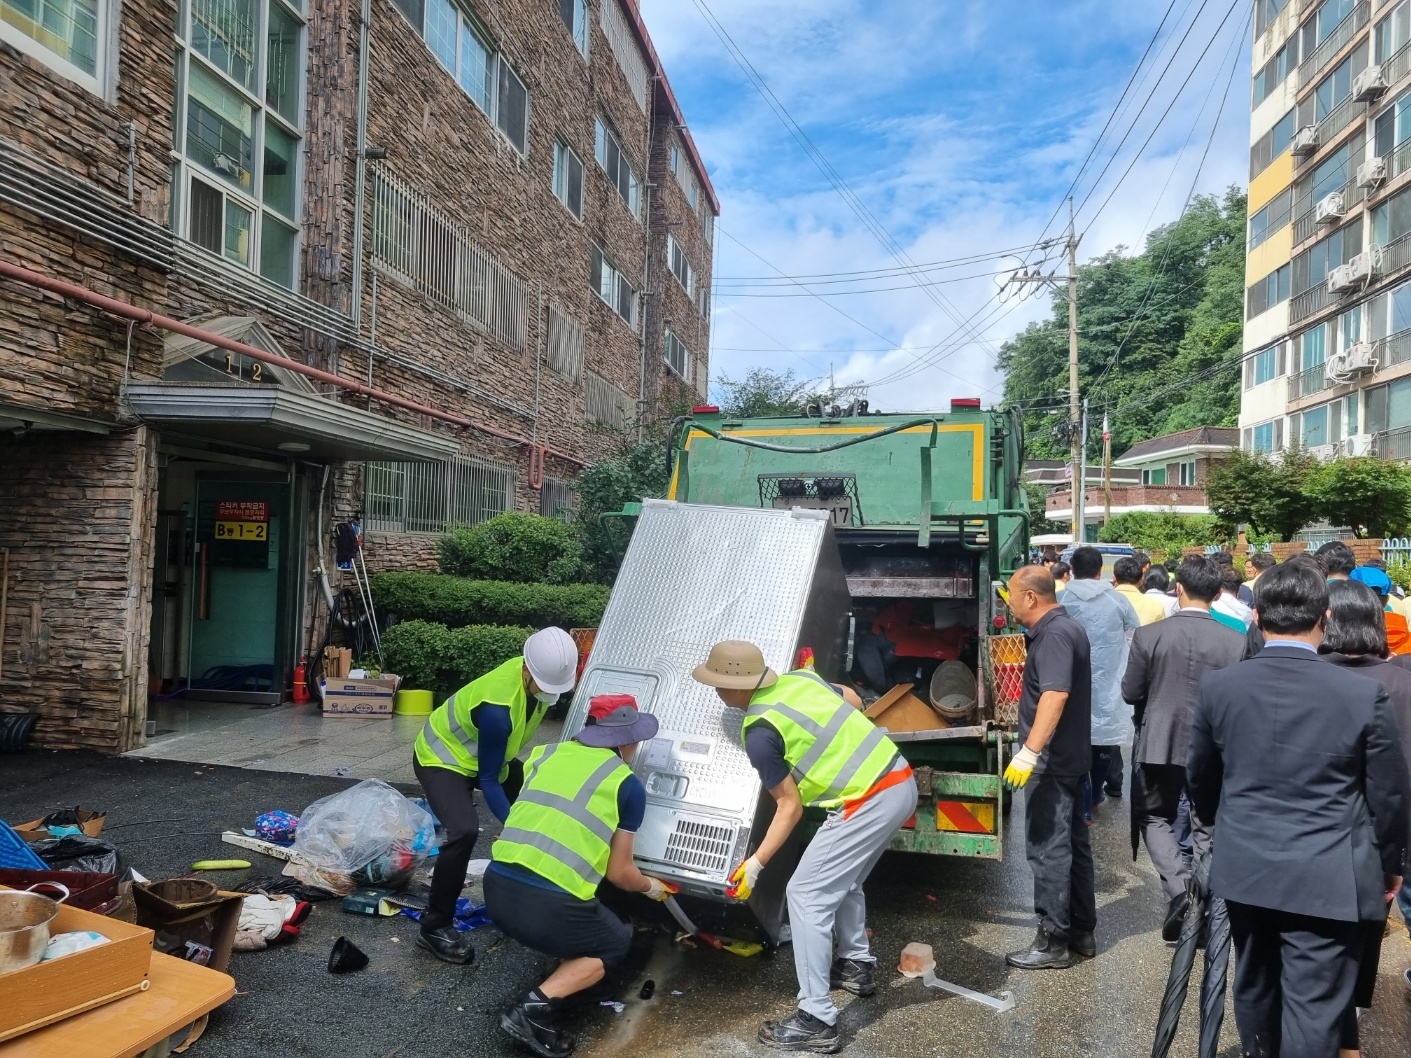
1122;556;1245;941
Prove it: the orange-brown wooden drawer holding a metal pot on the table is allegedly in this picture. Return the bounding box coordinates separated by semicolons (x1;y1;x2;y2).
0;904;155;1040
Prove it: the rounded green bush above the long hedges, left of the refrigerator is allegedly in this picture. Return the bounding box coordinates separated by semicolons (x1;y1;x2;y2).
437;512;586;584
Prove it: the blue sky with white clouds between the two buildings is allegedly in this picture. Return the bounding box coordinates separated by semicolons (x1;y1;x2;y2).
641;0;1250;411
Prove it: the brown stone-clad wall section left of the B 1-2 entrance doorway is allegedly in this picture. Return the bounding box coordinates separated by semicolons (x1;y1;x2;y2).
0;426;157;750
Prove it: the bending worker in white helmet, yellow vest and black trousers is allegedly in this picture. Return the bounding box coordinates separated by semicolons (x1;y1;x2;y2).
412;628;579;963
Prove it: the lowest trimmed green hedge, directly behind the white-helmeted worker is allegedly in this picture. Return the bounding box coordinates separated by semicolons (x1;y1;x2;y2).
382;621;535;700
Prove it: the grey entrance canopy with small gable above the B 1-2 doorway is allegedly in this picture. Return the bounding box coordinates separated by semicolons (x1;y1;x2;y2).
127;316;460;463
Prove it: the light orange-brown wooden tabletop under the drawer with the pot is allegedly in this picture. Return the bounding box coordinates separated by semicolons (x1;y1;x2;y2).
0;951;236;1058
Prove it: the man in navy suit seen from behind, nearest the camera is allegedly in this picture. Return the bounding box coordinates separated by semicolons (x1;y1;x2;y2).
1187;563;1411;1058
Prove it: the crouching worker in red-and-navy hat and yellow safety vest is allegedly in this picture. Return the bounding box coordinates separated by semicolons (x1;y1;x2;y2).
485;694;672;1058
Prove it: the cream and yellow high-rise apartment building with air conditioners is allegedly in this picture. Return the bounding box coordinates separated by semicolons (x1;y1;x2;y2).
1239;0;1411;458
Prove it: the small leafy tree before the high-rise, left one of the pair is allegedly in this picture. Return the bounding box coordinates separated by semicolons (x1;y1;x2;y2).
1205;447;1321;540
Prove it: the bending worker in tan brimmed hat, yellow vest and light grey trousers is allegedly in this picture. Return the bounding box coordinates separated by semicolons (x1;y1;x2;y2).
694;640;916;1054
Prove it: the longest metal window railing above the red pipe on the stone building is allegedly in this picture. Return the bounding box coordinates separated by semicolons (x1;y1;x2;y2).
371;164;529;353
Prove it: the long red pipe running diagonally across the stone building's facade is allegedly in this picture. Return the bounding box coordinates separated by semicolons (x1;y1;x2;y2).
0;260;588;467
